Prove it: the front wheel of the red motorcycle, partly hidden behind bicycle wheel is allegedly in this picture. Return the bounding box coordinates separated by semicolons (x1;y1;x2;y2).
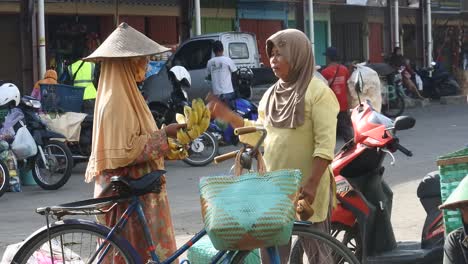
330;223;362;261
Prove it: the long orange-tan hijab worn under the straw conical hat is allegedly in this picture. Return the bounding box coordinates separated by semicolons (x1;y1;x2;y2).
86;57;158;182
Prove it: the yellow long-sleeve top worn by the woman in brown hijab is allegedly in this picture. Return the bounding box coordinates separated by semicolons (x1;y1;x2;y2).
240;77;340;223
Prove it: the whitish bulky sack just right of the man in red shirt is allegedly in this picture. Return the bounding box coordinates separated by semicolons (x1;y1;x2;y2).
348;64;382;112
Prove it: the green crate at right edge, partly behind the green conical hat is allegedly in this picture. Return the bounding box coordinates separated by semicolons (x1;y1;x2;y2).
437;148;468;234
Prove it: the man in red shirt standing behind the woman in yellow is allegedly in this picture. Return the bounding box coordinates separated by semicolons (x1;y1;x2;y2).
322;47;354;142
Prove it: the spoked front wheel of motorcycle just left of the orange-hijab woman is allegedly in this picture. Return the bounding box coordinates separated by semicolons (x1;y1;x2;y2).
32;140;73;190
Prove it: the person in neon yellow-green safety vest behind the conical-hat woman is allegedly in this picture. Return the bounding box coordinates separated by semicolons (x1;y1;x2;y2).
68;53;97;113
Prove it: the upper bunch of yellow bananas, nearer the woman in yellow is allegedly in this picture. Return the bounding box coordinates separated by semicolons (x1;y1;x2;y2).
176;98;211;144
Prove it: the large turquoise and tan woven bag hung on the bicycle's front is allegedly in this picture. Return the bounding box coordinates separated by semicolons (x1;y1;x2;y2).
200;170;302;250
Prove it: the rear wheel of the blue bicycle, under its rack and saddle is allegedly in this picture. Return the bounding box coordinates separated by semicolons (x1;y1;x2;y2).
12;223;137;264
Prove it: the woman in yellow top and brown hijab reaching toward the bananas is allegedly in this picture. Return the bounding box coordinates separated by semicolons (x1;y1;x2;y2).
210;29;339;263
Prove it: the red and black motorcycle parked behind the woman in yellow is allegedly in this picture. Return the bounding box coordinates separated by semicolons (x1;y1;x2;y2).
331;100;444;264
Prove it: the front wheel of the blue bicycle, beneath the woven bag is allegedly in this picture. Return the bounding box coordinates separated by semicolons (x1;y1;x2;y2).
231;225;360;264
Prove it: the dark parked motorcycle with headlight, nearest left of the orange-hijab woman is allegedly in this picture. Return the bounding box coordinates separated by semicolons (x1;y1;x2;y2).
15;96;73;190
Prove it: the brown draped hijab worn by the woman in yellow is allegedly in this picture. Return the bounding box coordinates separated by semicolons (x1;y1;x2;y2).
265;29;314;128
